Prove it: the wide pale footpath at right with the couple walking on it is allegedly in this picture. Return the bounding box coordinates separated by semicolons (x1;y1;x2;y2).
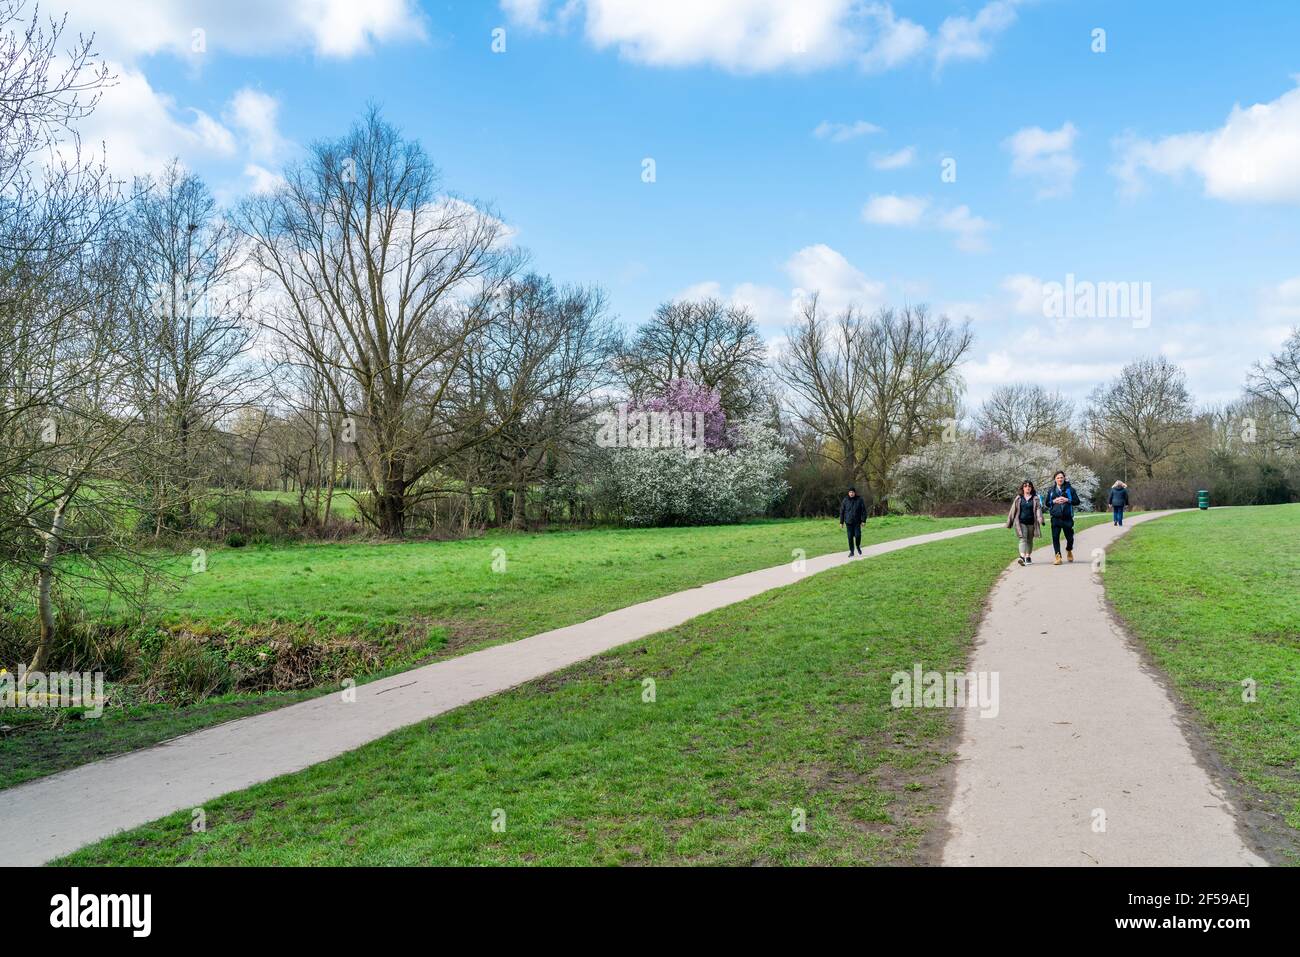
944;512;1265;866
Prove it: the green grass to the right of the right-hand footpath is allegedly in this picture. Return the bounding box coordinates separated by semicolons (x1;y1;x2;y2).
1105;505;1300;863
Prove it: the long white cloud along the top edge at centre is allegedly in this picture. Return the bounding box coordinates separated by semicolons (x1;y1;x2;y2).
501;0;1018;73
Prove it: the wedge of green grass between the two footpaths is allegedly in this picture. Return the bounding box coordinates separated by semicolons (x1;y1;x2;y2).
55;522;1015;865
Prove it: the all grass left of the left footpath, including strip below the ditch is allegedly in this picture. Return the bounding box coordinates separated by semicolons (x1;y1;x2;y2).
0;516;988;788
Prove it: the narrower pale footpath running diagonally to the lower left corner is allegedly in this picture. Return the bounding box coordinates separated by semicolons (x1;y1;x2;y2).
0;525;997;865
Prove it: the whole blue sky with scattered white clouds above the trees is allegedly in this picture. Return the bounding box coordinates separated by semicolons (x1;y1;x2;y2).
64;0;1300;403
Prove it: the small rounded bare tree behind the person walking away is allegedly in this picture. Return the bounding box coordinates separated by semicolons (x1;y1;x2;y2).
1087;356;1193;479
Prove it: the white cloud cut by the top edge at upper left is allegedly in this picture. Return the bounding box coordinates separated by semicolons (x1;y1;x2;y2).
60;0;424;61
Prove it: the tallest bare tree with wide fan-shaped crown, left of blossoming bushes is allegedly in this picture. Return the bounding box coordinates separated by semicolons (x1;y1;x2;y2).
239;109;519;536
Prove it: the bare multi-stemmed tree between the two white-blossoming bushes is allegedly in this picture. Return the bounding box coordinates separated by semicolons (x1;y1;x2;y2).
779;296;972;510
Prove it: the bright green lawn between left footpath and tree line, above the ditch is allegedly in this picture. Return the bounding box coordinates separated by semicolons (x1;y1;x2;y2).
87;516;988;650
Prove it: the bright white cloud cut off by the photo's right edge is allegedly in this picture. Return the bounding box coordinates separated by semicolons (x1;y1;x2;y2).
1112;78;1300;203
